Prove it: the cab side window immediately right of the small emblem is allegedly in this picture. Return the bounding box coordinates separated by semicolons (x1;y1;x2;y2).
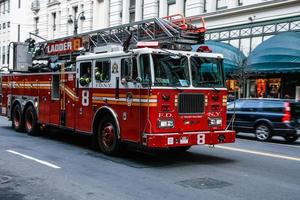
121;57;138;81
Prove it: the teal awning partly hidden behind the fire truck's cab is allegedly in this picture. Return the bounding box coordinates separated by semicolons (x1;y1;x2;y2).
192;41;246;75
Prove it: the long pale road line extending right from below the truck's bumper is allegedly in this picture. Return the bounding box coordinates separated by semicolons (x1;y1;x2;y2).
215;146;300;161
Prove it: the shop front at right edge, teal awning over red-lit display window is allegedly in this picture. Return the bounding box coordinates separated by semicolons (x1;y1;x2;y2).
247;32;300;99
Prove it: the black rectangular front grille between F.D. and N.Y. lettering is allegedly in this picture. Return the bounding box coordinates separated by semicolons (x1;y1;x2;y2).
178;94;204;114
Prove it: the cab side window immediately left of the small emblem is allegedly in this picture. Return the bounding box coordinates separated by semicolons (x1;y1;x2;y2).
95;60;110;82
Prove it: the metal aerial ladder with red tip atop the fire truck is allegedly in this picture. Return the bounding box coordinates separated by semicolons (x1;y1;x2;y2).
34;14;206;59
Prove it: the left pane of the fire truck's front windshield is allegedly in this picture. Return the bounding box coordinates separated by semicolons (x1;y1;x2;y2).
152;54;190;87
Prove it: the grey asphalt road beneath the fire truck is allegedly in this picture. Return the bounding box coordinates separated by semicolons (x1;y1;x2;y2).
0;117;300;200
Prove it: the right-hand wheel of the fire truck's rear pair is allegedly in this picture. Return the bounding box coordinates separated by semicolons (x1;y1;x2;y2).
24;106;40;136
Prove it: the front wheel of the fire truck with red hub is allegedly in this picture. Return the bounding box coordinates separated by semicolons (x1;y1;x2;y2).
95;116;122;156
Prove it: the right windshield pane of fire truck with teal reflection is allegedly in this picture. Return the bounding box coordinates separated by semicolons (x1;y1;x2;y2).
190;56;224;87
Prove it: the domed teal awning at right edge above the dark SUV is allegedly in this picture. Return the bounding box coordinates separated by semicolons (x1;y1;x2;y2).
247;32;300;74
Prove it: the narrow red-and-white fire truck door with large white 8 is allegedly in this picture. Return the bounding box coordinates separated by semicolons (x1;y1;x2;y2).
75;61;93;133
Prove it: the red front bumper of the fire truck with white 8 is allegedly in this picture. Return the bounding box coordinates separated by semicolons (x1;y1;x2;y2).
143;130;235;148
